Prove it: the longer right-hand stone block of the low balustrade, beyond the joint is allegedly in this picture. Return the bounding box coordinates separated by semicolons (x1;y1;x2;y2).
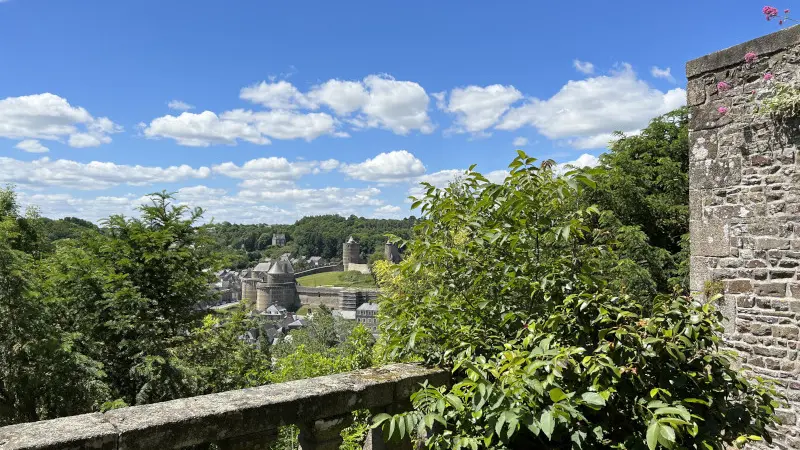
99;364;449;450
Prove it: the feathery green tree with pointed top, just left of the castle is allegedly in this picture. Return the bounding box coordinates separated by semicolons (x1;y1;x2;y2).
42;193;219;404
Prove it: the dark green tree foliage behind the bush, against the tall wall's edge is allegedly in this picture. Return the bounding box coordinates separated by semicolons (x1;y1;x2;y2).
585;108;689;292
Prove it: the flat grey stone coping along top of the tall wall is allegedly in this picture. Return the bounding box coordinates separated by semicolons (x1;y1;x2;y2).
686;25;800;79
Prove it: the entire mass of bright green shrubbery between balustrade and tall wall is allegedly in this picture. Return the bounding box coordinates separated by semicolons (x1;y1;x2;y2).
375;152;779;450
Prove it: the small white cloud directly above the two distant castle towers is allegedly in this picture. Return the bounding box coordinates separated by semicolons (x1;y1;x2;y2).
339;150;425;183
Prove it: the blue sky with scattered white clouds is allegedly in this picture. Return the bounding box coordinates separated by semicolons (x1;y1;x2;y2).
0;0;786;223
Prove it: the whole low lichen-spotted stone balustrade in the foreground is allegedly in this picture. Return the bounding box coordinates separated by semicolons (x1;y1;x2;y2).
0;364;449;450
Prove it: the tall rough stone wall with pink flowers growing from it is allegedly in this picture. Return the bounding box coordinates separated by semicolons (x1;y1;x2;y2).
686;27;800;449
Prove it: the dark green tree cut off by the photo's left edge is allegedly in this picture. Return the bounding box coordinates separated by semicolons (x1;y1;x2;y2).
0;188;108;425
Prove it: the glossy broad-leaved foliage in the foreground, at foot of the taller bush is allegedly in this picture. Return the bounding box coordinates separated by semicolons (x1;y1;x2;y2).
377;294;779;450
